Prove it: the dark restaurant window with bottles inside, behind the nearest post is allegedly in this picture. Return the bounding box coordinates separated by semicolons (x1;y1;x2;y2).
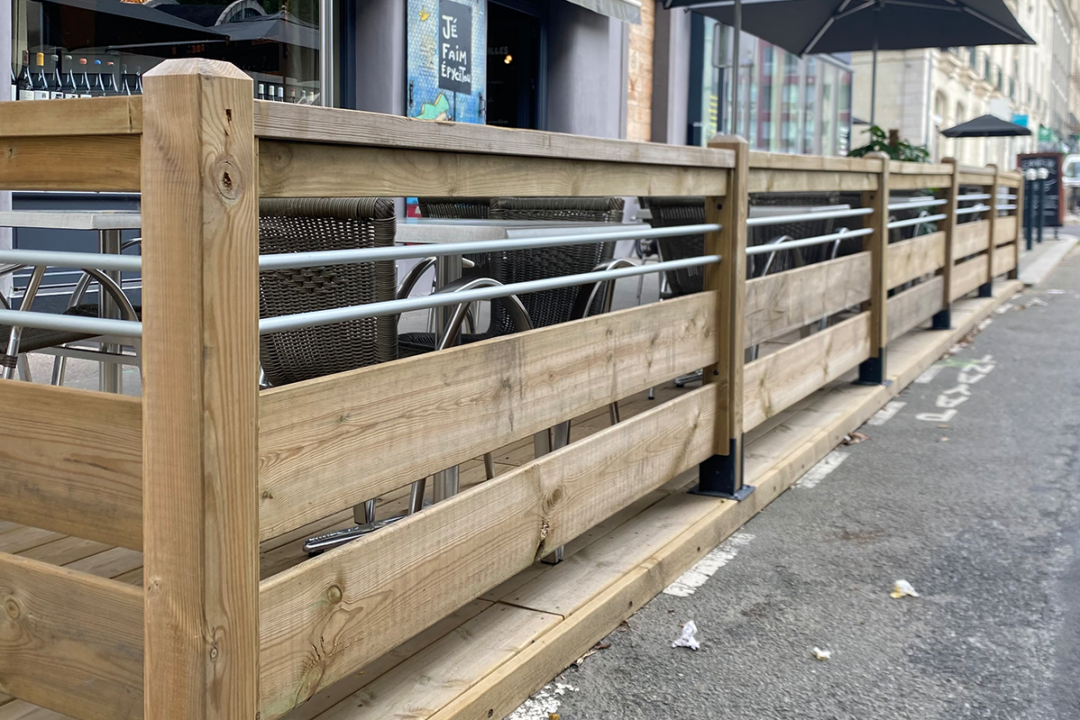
12;0;328;105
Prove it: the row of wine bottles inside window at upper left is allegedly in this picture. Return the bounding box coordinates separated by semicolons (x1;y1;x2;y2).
11;47;143;100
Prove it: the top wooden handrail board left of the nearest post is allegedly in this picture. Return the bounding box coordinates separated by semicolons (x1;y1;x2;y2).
0;95;143;137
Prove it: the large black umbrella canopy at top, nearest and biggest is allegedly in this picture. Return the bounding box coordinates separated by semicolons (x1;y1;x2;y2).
665;0;1035;55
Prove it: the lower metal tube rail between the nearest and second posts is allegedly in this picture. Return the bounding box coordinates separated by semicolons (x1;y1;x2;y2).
259;255;720;335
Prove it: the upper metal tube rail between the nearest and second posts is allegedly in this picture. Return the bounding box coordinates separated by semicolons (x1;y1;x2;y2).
259;223;720;270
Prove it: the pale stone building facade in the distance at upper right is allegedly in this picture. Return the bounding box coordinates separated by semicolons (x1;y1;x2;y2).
851;0;1080;167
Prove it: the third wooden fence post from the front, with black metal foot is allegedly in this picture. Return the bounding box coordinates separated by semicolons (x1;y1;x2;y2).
858;152;890;385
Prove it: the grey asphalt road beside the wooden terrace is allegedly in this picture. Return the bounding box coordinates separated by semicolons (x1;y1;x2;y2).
533;253;1080;720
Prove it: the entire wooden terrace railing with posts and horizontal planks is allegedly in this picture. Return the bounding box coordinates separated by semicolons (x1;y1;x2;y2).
0;60;1023;720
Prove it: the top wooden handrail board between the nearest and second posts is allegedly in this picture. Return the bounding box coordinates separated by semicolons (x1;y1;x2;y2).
255;100;734;169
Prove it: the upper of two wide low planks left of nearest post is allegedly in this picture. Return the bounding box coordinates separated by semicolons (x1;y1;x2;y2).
0;380;143;549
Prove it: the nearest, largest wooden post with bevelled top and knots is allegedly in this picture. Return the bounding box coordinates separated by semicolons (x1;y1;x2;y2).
141;59;259;720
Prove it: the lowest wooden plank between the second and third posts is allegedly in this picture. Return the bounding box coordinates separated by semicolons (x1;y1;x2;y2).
743;312;870;432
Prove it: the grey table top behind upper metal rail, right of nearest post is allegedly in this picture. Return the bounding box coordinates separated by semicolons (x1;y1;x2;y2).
396;218;649;245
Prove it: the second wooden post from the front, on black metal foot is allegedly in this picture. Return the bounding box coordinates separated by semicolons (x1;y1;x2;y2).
693;135;754;500
